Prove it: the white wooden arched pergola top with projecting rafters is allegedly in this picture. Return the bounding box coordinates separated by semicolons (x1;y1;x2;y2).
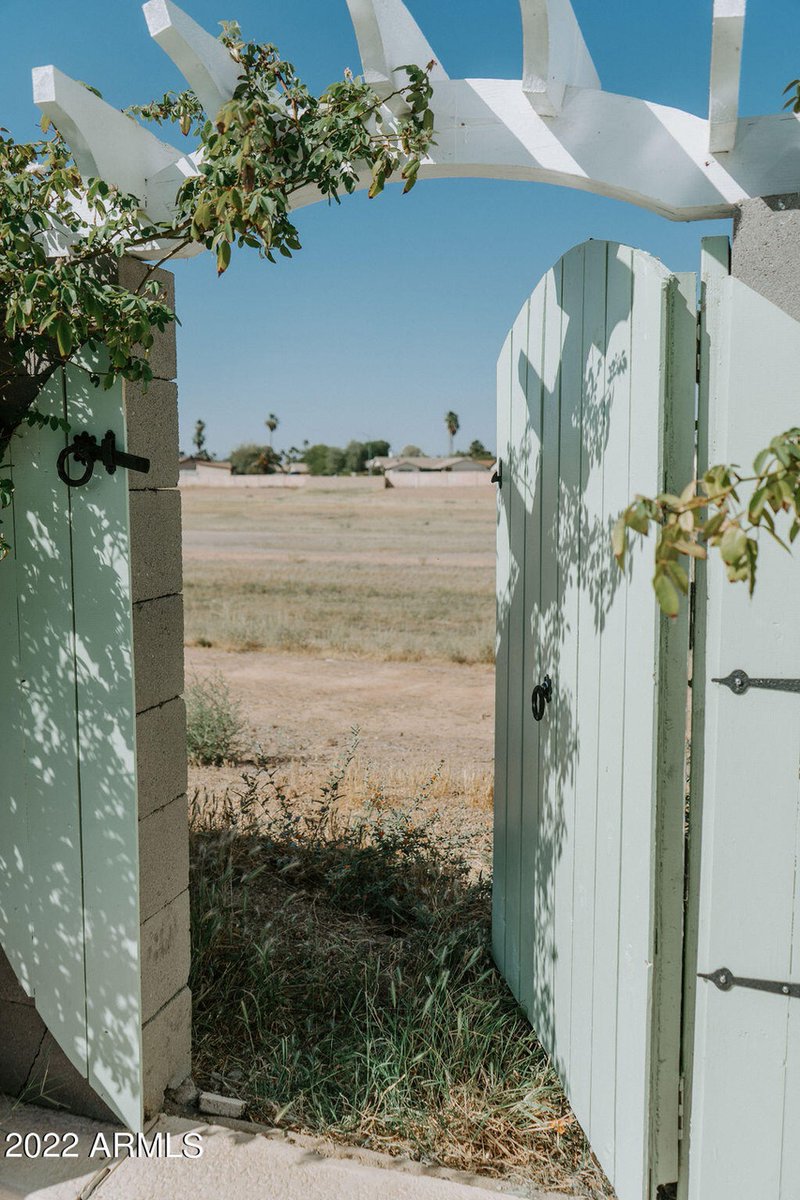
34;0;800;255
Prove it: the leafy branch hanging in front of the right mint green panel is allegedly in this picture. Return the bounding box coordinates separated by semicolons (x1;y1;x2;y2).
612;427;800;617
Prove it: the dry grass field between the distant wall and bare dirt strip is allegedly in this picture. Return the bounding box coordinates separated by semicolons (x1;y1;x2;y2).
184;486;495;662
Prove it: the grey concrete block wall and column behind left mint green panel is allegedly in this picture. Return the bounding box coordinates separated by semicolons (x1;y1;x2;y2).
0;260;192;1120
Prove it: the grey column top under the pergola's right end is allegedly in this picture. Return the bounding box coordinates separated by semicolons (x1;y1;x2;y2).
730;192;800;316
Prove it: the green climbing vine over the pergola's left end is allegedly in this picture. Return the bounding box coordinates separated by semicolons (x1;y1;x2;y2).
0;22;433;557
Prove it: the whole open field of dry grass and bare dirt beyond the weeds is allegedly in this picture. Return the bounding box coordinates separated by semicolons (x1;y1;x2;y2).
182;484;495;815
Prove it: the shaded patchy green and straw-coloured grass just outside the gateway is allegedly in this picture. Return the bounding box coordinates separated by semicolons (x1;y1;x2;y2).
191;755;609;1196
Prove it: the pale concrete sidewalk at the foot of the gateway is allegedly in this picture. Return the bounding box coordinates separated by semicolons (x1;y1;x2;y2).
0;1098;564;1200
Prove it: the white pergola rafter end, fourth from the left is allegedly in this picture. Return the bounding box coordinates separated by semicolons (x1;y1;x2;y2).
519;0;600;116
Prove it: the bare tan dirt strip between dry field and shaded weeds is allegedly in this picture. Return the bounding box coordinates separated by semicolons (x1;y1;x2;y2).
186;647;494;778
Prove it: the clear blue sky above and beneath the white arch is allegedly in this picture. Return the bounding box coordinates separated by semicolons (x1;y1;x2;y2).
0;0;800;455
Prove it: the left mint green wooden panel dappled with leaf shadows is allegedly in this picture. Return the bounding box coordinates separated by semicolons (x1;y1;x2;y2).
0;367;142;1129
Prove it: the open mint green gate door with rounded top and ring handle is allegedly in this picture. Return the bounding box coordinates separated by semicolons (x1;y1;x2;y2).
494;241;694;1200
